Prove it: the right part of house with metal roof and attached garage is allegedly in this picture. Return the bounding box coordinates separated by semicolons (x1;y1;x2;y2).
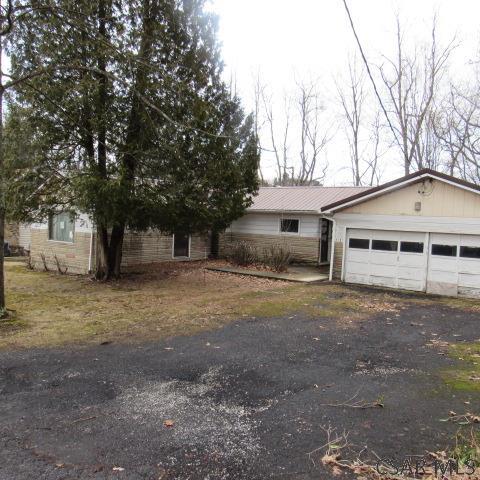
221;169;480;298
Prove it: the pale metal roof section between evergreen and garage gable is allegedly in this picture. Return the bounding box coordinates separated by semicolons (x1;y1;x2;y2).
248;187;371;213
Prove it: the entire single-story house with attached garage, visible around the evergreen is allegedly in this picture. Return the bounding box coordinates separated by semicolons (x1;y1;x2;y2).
25;169;480;298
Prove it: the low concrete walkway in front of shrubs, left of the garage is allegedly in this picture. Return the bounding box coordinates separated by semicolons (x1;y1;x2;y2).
207;265;328;283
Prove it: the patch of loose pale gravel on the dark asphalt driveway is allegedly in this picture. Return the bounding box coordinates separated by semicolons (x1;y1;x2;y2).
112;367;261;466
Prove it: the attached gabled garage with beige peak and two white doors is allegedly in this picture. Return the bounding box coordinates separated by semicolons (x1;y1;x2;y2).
322;170;480;298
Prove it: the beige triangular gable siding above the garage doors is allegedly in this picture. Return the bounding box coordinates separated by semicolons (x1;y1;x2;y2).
341;180;480;218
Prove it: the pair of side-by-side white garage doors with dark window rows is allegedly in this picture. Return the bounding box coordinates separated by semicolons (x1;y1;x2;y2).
345;228;480;298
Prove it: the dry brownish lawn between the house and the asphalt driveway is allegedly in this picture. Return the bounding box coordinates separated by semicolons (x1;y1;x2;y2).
0;262;478;348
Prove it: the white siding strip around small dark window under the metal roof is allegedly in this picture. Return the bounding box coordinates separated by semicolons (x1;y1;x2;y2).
227;213;321;237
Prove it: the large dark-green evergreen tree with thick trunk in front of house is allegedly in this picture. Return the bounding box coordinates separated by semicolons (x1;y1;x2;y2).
8;0;259;279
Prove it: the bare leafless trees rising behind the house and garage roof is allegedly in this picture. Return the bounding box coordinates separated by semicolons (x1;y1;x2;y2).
254;12;480;186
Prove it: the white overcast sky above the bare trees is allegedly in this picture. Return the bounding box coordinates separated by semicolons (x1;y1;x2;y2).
211;0;480;185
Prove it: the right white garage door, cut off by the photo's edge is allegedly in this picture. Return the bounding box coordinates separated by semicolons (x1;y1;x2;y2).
427;233;480;298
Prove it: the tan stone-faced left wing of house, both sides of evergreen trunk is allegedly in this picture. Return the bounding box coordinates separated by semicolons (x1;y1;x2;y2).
30;213;210;275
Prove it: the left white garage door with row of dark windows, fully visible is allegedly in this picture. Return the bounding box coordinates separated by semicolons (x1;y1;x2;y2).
345;229;428;291
